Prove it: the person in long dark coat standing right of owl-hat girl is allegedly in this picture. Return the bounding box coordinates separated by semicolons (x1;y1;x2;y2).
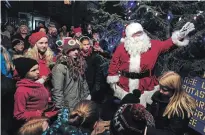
80;36;110;103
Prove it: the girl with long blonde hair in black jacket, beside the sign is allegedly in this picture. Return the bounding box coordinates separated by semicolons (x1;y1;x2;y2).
147;72;196;135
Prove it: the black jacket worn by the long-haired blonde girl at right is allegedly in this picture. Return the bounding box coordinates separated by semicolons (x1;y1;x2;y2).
147;91;189;135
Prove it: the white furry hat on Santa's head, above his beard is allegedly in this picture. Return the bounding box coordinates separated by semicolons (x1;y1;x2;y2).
125;23;143;37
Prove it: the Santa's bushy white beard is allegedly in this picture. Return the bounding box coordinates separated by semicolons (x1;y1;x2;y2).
124;33;151;56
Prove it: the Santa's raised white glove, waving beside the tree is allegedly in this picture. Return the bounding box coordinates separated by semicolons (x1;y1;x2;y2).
178;22;195;40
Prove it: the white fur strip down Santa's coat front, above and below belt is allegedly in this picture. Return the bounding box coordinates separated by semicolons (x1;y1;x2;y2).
129;54;141;92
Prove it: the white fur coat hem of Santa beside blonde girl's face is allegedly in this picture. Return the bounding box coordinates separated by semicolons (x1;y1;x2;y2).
140;85;159;108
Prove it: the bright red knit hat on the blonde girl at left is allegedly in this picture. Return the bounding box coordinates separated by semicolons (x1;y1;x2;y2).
28;32;48;46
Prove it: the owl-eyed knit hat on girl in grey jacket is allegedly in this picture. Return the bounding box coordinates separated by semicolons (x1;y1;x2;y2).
63;39;80;54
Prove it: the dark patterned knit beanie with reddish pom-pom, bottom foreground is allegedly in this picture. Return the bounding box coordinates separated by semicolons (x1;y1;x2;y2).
110;104;155;135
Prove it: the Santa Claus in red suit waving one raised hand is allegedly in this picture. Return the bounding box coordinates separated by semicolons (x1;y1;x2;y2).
107;22;195;106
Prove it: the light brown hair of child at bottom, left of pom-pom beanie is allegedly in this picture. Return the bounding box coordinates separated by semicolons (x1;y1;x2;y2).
69;100;100;130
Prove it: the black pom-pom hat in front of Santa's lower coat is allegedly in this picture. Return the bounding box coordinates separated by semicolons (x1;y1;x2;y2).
120;89;141;104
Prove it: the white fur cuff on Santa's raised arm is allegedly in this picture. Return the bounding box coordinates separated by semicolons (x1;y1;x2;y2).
172;31;189;46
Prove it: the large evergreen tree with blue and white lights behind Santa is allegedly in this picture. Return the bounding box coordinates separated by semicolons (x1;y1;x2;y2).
88;1;205;76
